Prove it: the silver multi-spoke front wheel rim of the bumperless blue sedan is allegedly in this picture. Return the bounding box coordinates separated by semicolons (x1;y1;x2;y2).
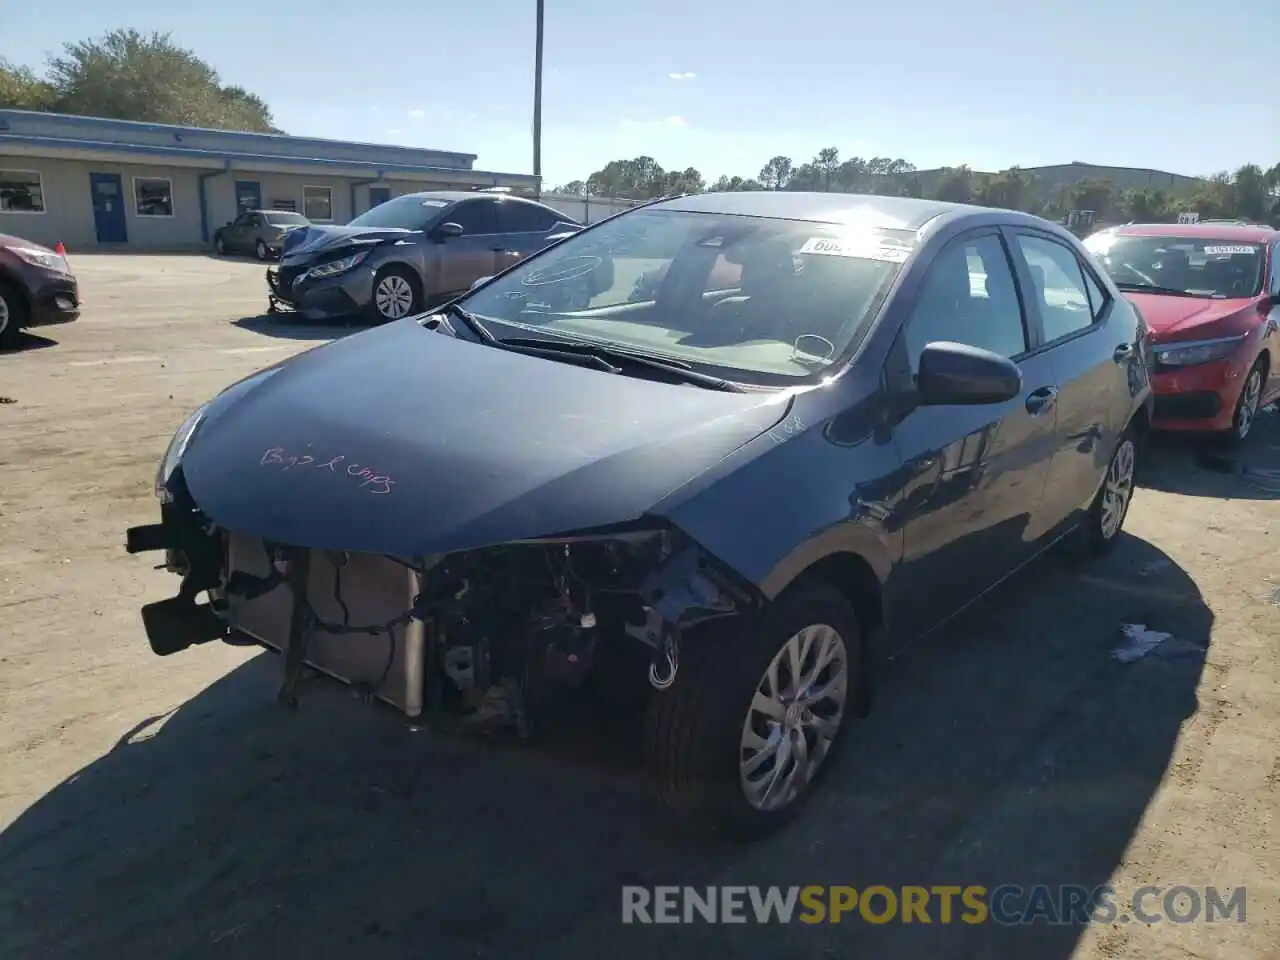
739;623;849;812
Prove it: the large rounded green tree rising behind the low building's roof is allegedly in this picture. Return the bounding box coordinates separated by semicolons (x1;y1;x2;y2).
28;29;279;133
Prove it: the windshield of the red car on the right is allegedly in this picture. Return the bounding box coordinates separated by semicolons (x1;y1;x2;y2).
1084;233;1262;300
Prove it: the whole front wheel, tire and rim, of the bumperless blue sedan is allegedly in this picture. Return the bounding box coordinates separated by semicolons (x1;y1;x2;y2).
645;584;861;838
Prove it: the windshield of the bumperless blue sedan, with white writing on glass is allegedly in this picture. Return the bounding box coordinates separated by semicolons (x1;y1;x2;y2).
462;209;915;385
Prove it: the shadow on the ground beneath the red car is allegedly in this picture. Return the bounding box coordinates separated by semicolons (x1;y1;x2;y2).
1140;403;1280;500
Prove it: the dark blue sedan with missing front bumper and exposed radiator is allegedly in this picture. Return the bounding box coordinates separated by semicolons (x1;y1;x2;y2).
128;192;1151;836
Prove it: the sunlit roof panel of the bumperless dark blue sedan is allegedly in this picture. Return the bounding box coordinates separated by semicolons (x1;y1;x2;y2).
652;189;988;230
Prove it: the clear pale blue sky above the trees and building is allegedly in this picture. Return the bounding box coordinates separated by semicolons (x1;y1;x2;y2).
0;0;1280;184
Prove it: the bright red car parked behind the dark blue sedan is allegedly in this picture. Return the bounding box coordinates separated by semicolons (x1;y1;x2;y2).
1084;224;1280;442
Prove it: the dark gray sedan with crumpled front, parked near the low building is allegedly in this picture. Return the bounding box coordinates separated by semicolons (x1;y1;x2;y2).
266;191;582;320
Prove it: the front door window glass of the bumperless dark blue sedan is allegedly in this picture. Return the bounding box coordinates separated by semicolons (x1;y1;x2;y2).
904;234;1027;372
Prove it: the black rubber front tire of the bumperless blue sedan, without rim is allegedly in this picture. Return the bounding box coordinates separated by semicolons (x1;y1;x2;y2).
644;582;863;840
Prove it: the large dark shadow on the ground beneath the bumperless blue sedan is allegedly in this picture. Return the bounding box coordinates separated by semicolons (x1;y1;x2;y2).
0;538;1213;960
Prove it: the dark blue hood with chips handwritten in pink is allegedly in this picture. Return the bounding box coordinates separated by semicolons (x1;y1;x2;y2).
182;320;788;557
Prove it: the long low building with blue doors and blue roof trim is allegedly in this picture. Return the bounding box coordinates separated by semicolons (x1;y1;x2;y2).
0;110;539;251
